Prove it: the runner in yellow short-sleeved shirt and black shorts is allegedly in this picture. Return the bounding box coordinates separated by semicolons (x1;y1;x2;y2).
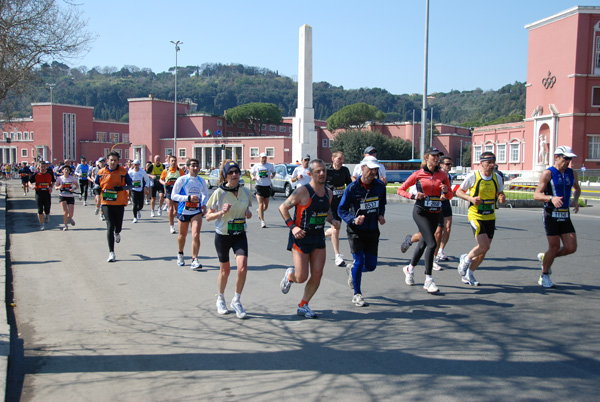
456;152;505;286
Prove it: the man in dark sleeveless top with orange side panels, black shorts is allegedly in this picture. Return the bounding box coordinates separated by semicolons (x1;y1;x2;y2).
279;159;340;318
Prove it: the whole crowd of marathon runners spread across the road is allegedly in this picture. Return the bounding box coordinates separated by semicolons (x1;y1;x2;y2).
18;146;581;318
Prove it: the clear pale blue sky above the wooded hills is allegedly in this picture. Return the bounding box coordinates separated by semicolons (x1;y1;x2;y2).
67;0;600;94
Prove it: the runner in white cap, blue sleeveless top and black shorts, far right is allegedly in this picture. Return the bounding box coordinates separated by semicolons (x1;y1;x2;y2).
533;145;581;288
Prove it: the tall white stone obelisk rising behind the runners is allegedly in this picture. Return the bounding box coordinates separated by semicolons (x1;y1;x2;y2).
292;24;318;162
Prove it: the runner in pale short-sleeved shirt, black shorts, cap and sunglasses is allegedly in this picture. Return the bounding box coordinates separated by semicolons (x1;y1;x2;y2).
206;160;252;318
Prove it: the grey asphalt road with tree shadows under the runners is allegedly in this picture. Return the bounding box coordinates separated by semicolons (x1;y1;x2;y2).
7;184;600;402
